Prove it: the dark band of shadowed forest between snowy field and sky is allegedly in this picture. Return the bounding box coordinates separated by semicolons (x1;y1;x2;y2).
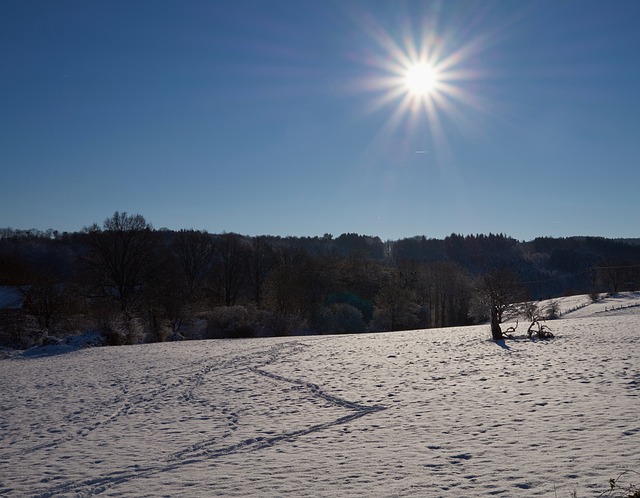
0;212;640;347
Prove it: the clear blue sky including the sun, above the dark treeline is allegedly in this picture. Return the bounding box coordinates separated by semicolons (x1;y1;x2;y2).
0;0;640;240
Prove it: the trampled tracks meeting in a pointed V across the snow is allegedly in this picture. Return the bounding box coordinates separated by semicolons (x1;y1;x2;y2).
29;342;385;498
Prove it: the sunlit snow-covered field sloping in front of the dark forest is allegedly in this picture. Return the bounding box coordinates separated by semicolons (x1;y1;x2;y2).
0;295;640;497
